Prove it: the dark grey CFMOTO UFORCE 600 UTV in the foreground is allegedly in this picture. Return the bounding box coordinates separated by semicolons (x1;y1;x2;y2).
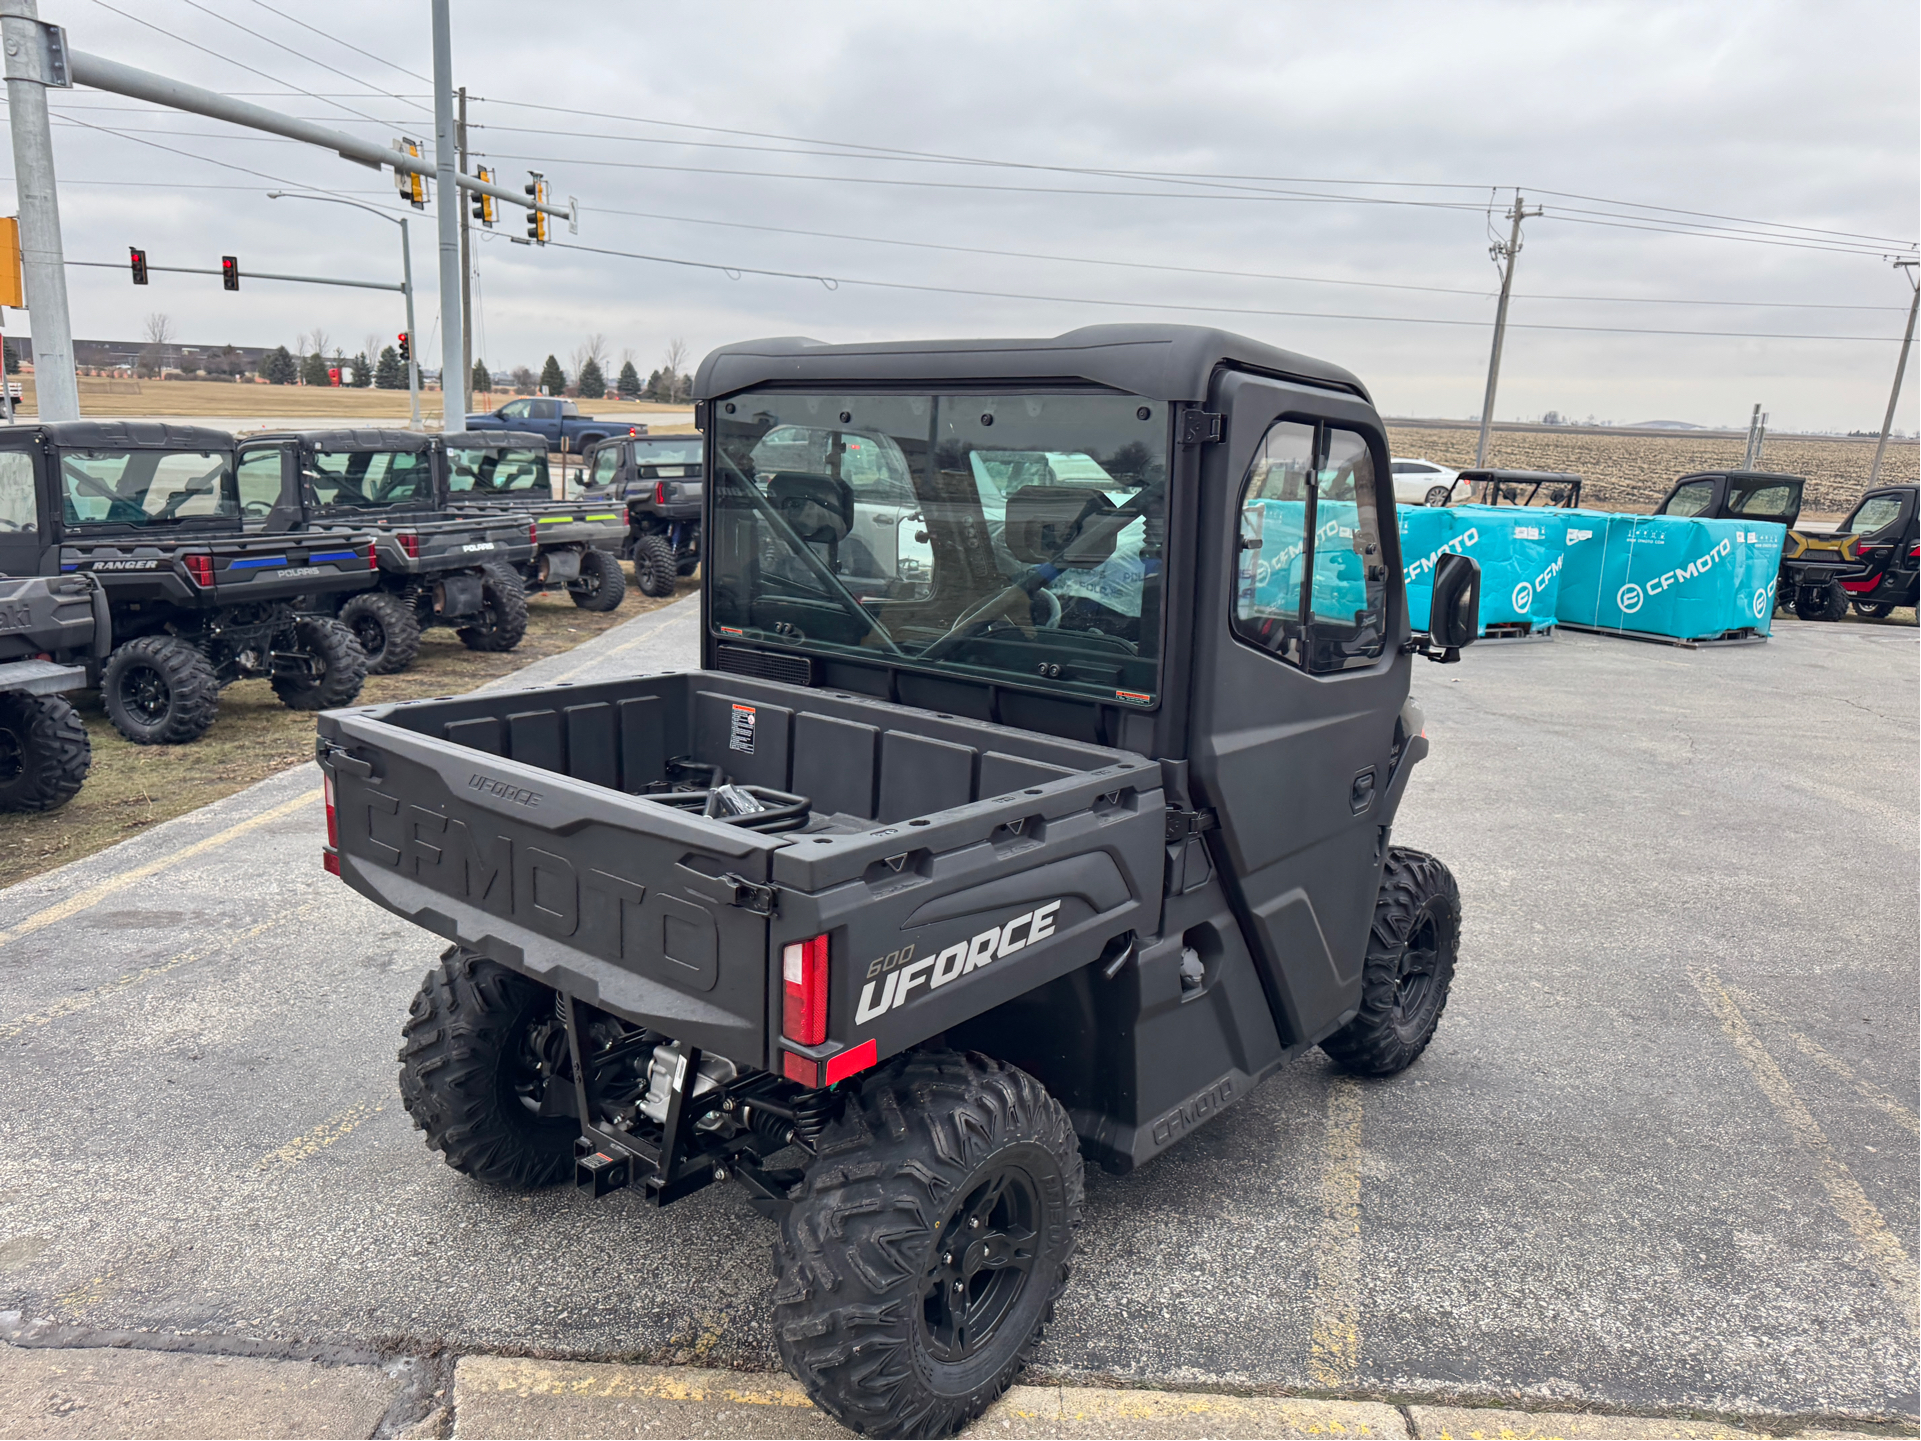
317;325;1479;1437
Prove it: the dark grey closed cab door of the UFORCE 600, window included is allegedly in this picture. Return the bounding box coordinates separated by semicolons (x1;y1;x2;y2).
1187;371;1410;1045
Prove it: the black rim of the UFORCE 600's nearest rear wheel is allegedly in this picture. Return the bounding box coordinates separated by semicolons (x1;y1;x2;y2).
920;1164;1041;1362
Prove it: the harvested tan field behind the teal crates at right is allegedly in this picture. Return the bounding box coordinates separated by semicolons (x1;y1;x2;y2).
1387;425;1921;521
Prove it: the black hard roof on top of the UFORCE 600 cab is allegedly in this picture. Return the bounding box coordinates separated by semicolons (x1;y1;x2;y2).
693;325;1372;402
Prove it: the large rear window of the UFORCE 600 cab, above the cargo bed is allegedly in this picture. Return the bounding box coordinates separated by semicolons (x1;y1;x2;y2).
711;392;1168;705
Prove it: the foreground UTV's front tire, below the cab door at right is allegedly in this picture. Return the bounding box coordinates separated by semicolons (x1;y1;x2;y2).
1322;845;1460;1076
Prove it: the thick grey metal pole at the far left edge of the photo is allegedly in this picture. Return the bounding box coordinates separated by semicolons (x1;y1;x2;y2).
0;0;81;421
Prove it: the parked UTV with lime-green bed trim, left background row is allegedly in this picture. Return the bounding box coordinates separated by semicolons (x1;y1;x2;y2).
440;430;626;611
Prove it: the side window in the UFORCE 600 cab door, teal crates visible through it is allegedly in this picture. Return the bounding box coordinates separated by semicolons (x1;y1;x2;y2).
1233;421;1387;672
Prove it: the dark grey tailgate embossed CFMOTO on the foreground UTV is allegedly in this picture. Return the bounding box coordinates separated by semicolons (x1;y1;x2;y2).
321;703;782;1064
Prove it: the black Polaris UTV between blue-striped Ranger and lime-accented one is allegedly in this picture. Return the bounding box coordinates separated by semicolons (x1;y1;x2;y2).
238;430;534;676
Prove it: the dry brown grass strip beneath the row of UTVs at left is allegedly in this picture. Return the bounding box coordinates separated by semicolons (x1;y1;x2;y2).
0;580;697;886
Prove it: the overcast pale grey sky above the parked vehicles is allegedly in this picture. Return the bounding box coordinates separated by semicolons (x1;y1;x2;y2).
8;0;1921;430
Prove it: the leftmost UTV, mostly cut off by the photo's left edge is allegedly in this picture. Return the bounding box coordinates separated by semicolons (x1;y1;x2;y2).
0;564;111;811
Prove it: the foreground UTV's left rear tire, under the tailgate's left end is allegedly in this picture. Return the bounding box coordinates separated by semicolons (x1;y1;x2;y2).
400;945;580;1191
